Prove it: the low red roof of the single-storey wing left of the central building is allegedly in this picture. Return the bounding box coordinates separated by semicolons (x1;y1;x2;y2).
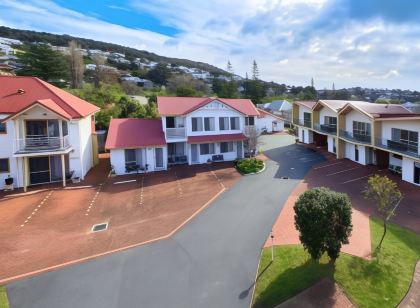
105;119;166;150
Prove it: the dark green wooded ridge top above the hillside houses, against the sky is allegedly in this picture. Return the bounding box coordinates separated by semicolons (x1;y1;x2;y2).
0;26;229;75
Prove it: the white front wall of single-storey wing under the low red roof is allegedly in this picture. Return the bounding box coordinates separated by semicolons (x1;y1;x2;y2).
110;146;168;175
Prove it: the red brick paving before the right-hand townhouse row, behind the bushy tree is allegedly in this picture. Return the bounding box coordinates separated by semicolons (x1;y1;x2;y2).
265;145;420;258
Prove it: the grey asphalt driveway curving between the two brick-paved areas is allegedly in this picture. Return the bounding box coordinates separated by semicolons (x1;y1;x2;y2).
7;135;323;308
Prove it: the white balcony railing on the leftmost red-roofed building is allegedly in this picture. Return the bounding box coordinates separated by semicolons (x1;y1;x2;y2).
14;136;70;154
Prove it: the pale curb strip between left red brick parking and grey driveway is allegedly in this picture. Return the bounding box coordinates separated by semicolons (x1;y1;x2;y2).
0;188;226;285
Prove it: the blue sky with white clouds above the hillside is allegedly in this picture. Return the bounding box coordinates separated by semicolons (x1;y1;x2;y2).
0;0;420;90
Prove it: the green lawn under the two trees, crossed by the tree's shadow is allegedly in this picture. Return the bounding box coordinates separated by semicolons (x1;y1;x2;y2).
254;218;420;308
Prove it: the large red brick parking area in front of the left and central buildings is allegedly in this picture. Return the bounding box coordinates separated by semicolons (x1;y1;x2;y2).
0;155;240;280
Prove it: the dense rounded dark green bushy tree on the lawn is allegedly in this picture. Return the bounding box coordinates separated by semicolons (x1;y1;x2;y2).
294;187;352;262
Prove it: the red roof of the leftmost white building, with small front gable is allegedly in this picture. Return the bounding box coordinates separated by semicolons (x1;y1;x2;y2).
0;76;100;119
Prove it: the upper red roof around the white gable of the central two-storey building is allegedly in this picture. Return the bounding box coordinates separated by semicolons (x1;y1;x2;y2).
157;96;259;116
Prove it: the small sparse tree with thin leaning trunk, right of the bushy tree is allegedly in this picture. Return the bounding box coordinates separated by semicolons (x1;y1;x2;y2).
364;175;403;251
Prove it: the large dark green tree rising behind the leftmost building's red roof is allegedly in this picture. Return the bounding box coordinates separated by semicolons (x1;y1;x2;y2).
18;44;69;83
